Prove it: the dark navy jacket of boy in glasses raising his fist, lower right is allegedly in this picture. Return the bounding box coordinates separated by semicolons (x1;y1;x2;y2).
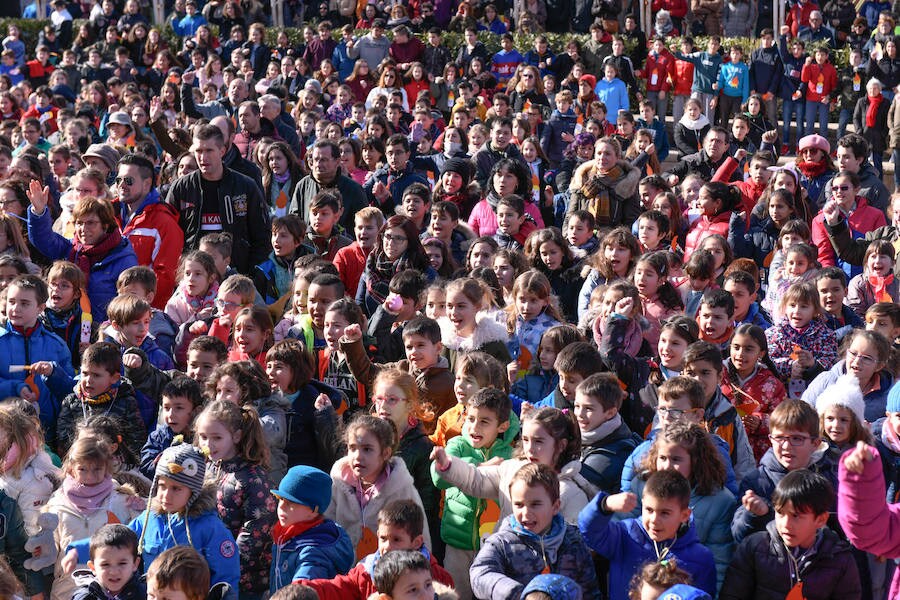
731;442;837;542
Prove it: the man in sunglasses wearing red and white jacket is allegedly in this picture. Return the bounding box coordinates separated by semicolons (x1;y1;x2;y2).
113;154;184;310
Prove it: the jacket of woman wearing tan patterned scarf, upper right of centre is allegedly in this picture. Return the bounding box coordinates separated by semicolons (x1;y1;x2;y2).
566;160;641;227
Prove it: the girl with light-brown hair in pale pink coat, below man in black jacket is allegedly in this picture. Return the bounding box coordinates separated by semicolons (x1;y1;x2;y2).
165;250;219;326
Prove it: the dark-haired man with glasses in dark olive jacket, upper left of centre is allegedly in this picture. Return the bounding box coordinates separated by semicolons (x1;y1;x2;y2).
288;139;368;231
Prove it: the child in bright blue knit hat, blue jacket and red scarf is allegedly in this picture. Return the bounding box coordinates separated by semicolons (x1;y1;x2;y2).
269;465;353;594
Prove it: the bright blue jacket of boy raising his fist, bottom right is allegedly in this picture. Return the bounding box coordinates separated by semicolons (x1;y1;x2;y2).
578;492;716;600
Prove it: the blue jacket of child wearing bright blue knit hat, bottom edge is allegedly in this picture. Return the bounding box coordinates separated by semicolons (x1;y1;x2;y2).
269;519;356;594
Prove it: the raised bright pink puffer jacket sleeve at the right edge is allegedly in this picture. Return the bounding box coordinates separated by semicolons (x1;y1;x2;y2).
838;448;900;598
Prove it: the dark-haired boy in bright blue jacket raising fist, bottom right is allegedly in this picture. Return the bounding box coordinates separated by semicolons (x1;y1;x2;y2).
578;470;716;600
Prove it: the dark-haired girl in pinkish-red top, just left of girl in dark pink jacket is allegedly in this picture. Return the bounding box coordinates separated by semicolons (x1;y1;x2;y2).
634;252;684;348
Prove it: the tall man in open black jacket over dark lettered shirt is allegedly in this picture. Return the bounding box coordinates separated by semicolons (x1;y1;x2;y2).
166;125;272;275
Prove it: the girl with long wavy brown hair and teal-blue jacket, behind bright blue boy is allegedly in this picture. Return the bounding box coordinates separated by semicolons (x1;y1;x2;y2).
631;421;737;585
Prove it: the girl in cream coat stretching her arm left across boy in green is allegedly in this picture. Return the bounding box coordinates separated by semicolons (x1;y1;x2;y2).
431;406;592;525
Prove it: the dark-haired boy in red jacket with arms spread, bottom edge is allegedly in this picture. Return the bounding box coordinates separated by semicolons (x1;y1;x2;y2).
303;500;455;600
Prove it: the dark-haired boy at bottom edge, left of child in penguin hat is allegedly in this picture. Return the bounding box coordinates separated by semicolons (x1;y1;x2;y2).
72;523;147;600
